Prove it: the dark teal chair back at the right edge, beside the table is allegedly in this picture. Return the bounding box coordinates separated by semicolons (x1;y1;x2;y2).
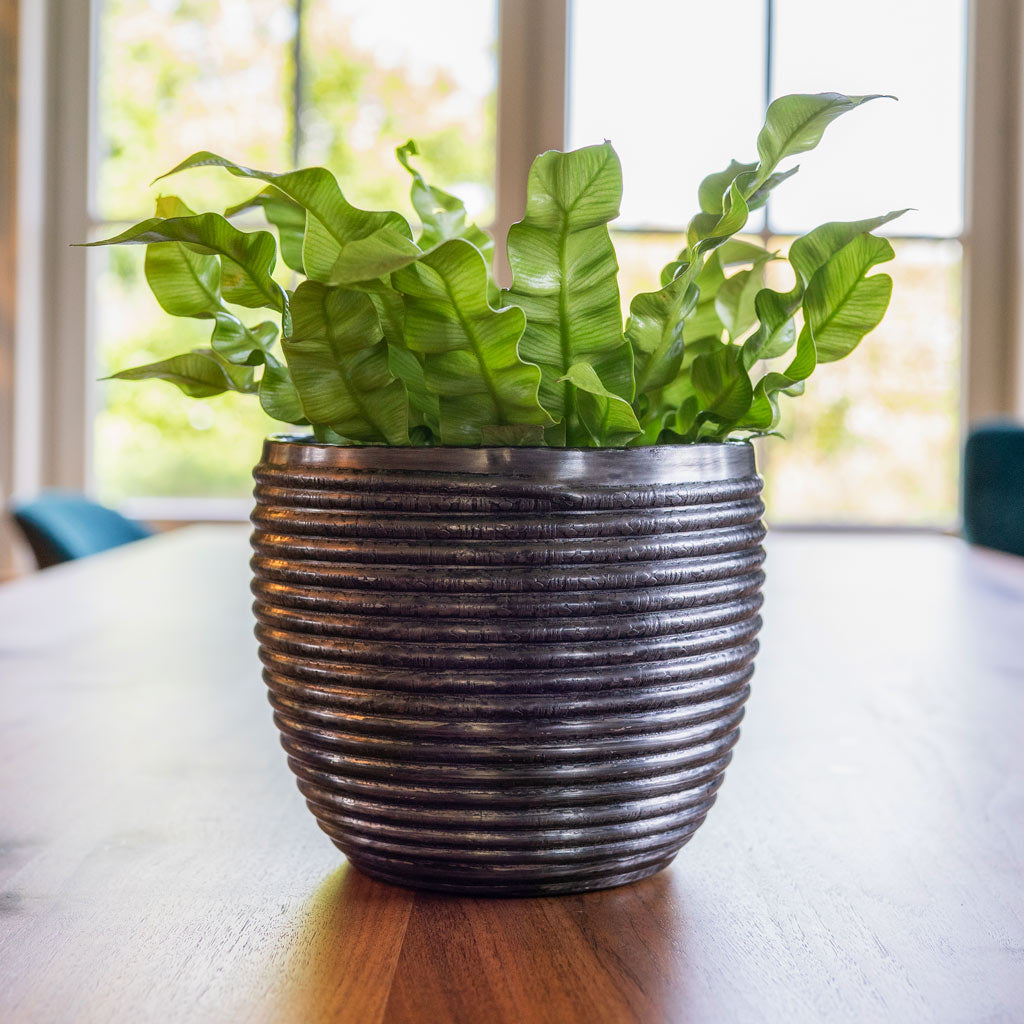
964;423;1024;555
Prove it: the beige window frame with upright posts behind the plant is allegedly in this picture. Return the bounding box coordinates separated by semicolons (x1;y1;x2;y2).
0;0;1024;552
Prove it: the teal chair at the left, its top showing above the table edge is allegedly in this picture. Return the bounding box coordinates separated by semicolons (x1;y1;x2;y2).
11;490;151;569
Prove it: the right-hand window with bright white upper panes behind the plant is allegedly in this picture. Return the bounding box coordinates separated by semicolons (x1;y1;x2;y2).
568;0;967;525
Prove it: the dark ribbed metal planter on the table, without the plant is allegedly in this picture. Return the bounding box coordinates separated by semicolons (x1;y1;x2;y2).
253;439;764;895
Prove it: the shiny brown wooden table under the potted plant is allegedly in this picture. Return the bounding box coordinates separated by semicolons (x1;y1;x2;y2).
0;526;1024;1024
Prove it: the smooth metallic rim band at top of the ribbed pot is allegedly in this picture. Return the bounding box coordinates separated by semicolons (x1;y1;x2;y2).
263;433;756;486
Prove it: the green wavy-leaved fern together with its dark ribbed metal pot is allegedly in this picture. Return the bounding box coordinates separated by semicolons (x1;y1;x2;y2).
96;93;898;894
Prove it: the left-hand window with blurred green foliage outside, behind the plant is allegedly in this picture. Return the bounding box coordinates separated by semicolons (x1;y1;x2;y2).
90;0;497;503
